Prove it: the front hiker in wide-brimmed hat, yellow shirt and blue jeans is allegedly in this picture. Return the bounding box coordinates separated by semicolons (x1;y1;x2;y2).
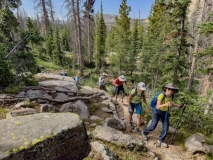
141;83;186;147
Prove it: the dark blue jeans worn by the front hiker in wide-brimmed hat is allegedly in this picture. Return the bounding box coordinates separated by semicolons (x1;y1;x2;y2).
143;110;169;142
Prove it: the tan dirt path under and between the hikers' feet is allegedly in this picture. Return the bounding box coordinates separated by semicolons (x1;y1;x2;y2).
115;97;205;160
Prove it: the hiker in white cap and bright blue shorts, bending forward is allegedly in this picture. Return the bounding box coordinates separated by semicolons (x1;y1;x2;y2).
128;82;149;134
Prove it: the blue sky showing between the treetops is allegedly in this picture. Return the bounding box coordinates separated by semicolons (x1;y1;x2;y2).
21;0;155;20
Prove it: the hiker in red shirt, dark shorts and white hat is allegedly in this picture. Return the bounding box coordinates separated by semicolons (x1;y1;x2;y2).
113;75;127;102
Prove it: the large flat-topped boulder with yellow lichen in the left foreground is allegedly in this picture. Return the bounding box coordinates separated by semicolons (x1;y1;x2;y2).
0;113;91;160
